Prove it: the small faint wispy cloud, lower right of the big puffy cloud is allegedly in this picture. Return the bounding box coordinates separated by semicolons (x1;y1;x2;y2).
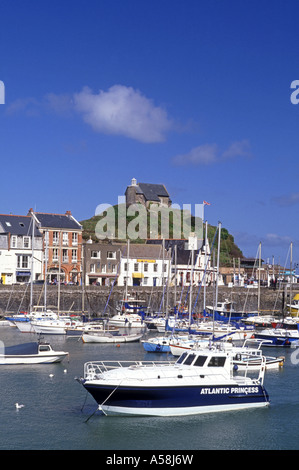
172;140;251;165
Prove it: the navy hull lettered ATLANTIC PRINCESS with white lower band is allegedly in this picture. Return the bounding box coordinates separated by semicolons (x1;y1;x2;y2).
82;381;269;416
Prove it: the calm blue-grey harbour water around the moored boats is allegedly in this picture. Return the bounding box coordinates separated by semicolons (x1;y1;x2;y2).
0;327;299;452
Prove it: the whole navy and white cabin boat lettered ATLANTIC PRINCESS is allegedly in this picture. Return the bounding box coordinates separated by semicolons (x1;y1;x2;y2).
77;348;269;416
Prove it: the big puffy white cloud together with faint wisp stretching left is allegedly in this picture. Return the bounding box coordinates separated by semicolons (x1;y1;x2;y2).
6;85;174;143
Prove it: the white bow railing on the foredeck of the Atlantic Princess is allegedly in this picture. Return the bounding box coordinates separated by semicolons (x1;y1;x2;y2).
84;361;173;379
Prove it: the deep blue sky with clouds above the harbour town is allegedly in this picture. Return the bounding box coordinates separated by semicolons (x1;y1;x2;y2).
0;0;299;265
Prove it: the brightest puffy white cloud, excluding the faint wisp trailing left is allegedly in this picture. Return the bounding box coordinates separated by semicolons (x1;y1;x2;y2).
74;85;172;143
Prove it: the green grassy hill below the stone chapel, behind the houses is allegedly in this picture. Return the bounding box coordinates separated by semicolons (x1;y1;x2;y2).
80;205;243;266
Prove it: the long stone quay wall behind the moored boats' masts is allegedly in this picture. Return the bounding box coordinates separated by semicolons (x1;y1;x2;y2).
0;285;298;317
